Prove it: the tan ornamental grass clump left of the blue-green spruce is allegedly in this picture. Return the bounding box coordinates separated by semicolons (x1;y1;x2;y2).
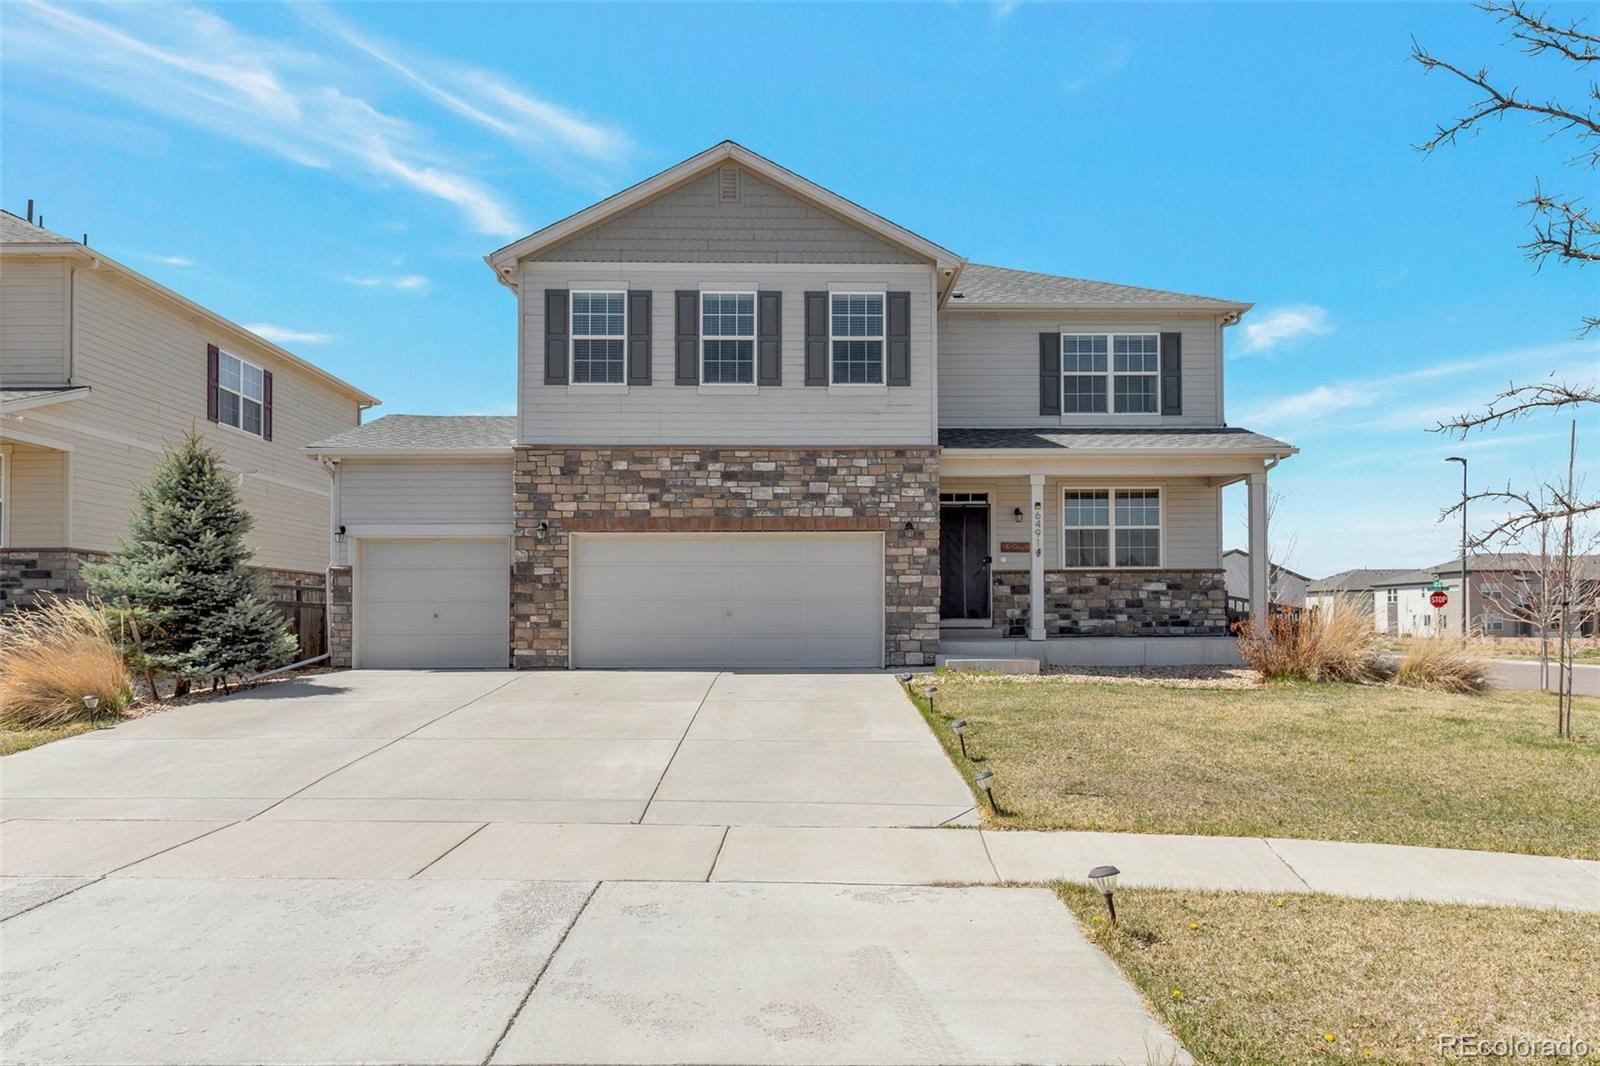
0;599;133;728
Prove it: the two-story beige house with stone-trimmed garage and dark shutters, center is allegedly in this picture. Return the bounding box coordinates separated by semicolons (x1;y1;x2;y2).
310;142;1294;667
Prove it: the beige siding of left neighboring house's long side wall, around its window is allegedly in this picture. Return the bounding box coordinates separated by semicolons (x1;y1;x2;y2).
0;269;358;570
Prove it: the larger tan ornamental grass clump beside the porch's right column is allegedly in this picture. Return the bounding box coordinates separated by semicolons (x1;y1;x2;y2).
1238;607;1389;683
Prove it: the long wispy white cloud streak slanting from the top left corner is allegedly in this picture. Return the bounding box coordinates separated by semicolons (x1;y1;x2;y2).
3;0;544;237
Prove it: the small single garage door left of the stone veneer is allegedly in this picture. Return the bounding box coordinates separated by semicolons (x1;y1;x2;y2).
355;538;510;669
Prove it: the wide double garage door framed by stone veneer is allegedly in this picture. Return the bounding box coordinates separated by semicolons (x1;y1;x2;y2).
570;533;883;667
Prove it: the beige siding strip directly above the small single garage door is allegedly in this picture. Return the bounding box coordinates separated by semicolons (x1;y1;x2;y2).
339;455;512;533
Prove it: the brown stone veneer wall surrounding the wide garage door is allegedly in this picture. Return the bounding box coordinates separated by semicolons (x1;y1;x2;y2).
512;445;939;667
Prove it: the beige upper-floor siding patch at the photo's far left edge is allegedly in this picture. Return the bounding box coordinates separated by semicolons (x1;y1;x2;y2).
0;256;69;387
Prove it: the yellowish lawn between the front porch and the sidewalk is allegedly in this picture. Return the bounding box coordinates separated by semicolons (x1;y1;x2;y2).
917;674;1600;858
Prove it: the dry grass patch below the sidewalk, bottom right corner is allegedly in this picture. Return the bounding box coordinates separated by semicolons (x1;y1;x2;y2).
1058;885;1600;1066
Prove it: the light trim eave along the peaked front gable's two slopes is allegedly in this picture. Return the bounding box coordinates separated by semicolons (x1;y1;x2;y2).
485;141;966;277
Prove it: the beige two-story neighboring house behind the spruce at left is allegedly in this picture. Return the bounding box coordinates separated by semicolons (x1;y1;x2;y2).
0;213;378;607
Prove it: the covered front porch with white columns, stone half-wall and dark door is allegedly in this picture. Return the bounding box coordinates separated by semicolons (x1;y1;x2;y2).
939;429;1293;666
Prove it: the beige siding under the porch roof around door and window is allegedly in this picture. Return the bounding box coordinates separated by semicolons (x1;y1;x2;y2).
939;477;1222;570
